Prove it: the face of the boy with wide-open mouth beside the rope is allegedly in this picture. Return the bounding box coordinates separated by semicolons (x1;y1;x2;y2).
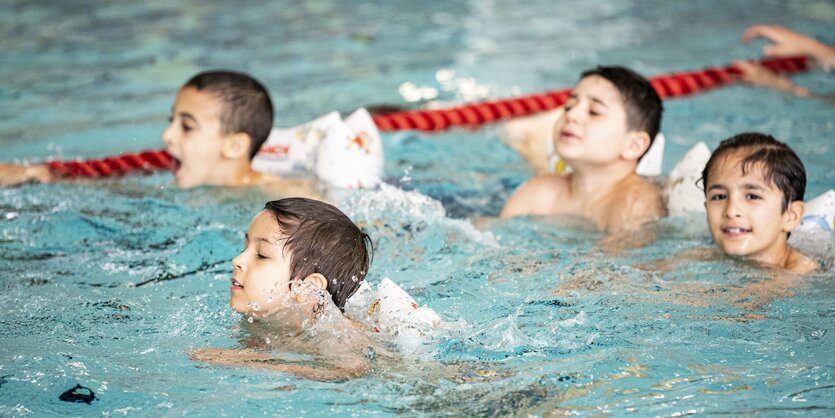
162;87;232;188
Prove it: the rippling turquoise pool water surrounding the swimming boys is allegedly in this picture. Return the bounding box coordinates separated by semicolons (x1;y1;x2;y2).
0;0;835;416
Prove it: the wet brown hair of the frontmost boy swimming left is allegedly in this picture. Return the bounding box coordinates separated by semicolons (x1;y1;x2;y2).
264;197;373;310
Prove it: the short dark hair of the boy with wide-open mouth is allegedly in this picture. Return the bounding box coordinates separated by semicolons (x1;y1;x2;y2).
183;71;273;160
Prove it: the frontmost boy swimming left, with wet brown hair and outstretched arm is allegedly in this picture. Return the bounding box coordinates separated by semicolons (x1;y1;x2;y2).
191;198;378;380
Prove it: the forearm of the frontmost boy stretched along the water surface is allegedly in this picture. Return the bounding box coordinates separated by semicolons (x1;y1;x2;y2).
194;348;368;382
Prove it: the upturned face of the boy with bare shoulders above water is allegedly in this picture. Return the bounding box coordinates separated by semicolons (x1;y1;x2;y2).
554;75;628;168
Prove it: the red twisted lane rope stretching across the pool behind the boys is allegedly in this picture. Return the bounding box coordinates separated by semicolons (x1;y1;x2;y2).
46;57;809;178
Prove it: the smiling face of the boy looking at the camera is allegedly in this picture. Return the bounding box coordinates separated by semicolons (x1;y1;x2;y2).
705;151;794;264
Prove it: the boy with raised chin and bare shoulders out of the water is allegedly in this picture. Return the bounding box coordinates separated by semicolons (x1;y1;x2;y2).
501;67;666;232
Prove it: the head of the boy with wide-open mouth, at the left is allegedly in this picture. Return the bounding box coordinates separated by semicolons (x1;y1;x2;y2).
162;71;273;188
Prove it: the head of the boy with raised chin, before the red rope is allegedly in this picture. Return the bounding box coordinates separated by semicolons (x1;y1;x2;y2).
554;67;663;169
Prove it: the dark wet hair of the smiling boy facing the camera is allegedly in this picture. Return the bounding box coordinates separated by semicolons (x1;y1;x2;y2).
701;132;806;212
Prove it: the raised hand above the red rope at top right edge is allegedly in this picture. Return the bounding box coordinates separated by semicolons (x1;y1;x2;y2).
742;25;835;63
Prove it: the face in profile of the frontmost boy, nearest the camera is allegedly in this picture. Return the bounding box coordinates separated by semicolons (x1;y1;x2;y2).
229;211;291;315
